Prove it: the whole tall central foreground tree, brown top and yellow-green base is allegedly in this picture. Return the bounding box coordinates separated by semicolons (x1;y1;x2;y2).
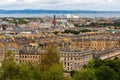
40;46;64;80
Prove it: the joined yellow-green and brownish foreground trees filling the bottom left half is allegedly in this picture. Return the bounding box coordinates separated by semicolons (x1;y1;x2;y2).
0;49;69;80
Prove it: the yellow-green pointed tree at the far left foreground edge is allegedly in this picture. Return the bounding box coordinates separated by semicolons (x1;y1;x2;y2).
0;51;19;80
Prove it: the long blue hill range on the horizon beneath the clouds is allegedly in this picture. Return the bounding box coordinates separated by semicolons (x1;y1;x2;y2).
0;9;120;14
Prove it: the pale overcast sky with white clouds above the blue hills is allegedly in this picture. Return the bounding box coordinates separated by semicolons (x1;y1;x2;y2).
0;0;120;11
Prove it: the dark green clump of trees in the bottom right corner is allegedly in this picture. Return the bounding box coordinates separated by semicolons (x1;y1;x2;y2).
71;58;120;80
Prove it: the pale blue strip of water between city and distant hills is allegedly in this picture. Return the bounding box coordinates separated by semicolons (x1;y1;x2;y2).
0;13;120;18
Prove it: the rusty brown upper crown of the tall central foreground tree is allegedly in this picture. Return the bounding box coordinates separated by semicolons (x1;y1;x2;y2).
40;46;60;71
